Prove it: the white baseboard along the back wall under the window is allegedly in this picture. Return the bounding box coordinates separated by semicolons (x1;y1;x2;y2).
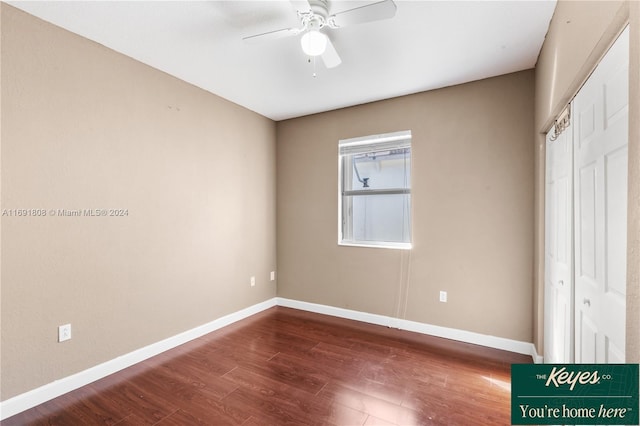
277;297;542;363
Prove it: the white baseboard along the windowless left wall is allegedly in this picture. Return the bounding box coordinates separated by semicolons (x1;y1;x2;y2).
0;297;277;420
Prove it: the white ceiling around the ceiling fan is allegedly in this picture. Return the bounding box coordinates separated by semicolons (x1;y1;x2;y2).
9;0;555;120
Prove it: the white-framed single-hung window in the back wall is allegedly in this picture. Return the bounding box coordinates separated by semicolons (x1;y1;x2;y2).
338;131;411;249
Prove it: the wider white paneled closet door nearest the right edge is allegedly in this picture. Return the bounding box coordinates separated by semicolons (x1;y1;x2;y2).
573;28;629;363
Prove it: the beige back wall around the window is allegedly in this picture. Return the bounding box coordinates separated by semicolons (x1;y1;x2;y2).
277;70;534;342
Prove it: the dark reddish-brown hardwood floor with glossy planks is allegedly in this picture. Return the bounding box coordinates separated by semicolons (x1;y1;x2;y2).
2;307;531;426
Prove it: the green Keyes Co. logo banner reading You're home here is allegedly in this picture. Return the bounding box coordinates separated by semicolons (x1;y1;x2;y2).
511;364;639;425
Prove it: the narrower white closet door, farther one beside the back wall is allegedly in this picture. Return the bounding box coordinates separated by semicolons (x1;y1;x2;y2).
544;120;573;364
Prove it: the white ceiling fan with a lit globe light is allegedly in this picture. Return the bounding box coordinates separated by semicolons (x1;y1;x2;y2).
243;0;396;68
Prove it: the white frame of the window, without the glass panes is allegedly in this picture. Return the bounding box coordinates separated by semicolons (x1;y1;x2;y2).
338;130;413;250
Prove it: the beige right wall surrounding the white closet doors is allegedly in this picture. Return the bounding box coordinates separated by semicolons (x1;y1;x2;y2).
534;0;640;362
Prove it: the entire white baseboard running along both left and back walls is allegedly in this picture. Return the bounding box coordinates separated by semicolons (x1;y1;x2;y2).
0;297;542;420
